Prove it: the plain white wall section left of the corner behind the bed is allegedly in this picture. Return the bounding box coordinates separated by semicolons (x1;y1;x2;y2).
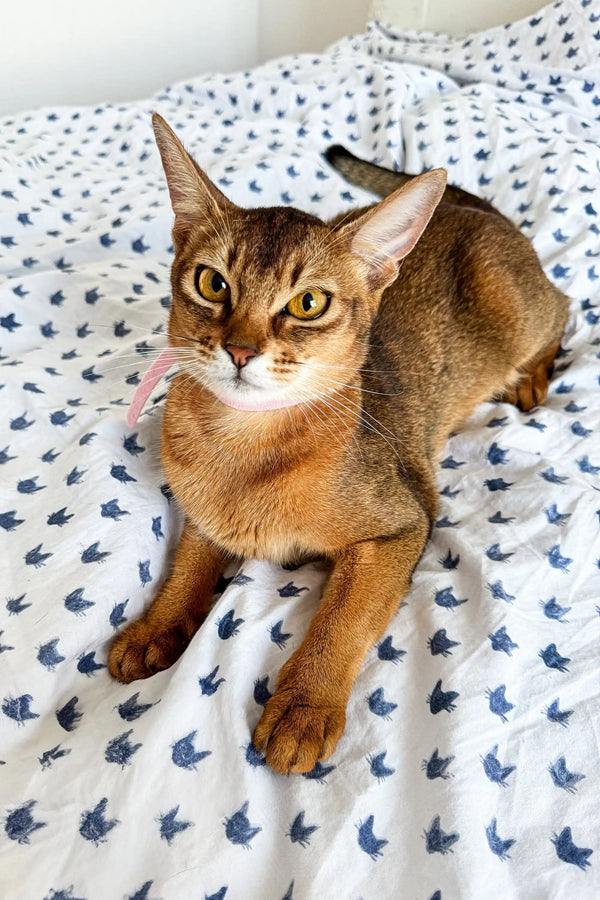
0;0;259;114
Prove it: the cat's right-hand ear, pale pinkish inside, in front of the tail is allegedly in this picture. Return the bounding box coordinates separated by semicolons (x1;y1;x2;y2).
341;169;446;290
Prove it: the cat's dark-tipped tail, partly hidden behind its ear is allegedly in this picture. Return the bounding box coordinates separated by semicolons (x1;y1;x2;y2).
325;144;501;215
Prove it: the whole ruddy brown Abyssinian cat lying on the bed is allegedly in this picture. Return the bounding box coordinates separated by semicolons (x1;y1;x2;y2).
109;115;568;773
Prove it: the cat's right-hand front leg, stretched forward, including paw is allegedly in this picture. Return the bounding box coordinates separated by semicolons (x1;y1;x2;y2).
254;523;428;774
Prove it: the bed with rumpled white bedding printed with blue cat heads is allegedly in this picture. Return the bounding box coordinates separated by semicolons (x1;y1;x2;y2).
0;0;600;900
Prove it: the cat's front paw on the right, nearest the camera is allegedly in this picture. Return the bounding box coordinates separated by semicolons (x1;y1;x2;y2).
253;689;346;775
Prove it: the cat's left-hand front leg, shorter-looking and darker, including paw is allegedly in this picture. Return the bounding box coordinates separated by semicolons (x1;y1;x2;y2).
108;519;226;683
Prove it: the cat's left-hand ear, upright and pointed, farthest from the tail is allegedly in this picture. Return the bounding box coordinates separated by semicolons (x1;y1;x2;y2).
152;113;234;242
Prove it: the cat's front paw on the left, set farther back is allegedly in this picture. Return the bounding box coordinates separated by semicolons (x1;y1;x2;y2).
108;619;189;684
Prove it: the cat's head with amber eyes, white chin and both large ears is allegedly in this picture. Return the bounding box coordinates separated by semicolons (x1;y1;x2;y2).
153;114;445;410
